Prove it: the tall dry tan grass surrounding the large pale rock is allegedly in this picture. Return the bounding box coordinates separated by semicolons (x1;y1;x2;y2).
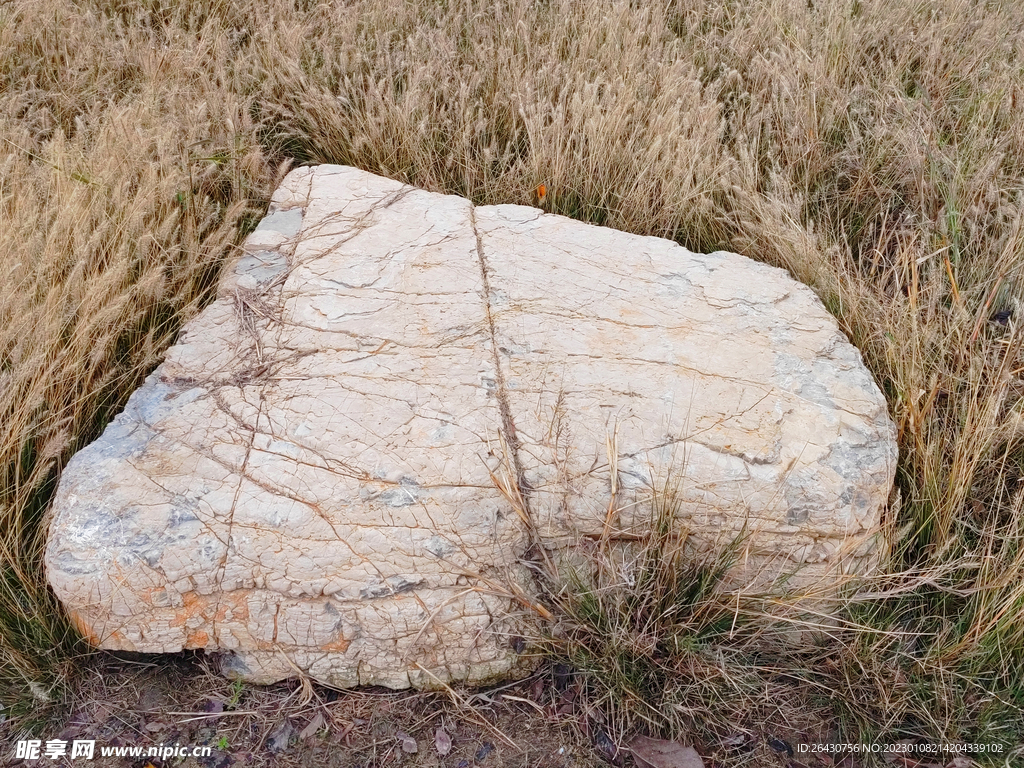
6;0;1024;761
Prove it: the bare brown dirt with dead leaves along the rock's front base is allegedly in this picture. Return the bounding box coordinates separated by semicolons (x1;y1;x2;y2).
0;654;827;768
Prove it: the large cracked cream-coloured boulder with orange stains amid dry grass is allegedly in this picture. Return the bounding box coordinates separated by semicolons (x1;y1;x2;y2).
46;166;896;688
